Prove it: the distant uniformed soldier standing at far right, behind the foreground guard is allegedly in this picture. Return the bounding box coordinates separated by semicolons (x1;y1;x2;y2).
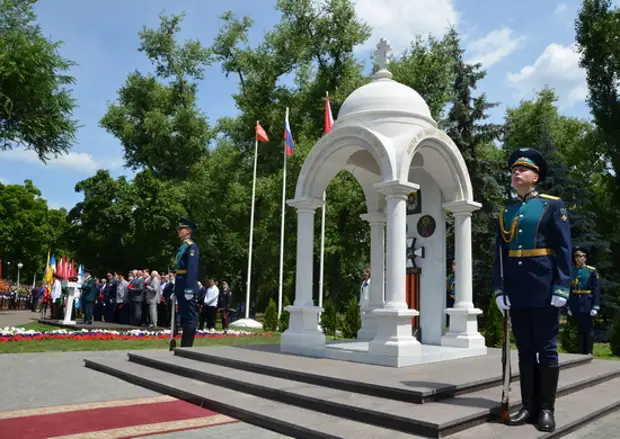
568;248;600;354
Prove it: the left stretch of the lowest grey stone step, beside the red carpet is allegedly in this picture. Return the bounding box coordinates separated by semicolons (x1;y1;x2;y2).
84;359;421;439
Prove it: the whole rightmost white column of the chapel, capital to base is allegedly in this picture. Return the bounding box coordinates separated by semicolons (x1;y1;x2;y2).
441;200;486;350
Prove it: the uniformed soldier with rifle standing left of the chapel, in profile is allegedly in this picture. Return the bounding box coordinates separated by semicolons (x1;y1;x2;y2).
172;218;200;347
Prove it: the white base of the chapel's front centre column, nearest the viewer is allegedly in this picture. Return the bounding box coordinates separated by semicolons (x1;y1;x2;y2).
368;308;422;357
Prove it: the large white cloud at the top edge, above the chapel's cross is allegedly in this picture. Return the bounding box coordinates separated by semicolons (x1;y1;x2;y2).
354;0;460;53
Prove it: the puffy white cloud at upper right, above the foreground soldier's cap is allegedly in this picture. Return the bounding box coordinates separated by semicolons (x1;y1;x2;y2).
508;43;588;108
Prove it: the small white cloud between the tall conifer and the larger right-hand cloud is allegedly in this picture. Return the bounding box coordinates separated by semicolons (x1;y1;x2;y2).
465;27;525;69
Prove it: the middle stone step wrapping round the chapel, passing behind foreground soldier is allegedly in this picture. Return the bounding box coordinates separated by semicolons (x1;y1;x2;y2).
121;351;620;437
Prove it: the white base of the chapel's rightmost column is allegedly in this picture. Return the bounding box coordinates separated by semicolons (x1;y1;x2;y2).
441;308;486;348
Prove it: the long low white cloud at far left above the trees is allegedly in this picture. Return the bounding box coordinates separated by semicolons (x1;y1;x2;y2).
0;148;122;174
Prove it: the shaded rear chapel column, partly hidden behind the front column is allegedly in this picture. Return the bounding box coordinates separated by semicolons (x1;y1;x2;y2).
357;212;385;341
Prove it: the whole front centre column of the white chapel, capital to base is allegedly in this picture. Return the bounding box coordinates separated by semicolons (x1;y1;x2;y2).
368;180;421;364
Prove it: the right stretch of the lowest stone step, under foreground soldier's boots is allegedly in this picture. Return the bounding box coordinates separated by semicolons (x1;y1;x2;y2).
450;378;620;439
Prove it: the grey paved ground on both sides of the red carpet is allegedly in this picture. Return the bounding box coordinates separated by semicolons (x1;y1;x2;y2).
0;351;285;439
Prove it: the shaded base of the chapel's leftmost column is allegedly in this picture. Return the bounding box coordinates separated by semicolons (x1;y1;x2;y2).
280;305;325;354
